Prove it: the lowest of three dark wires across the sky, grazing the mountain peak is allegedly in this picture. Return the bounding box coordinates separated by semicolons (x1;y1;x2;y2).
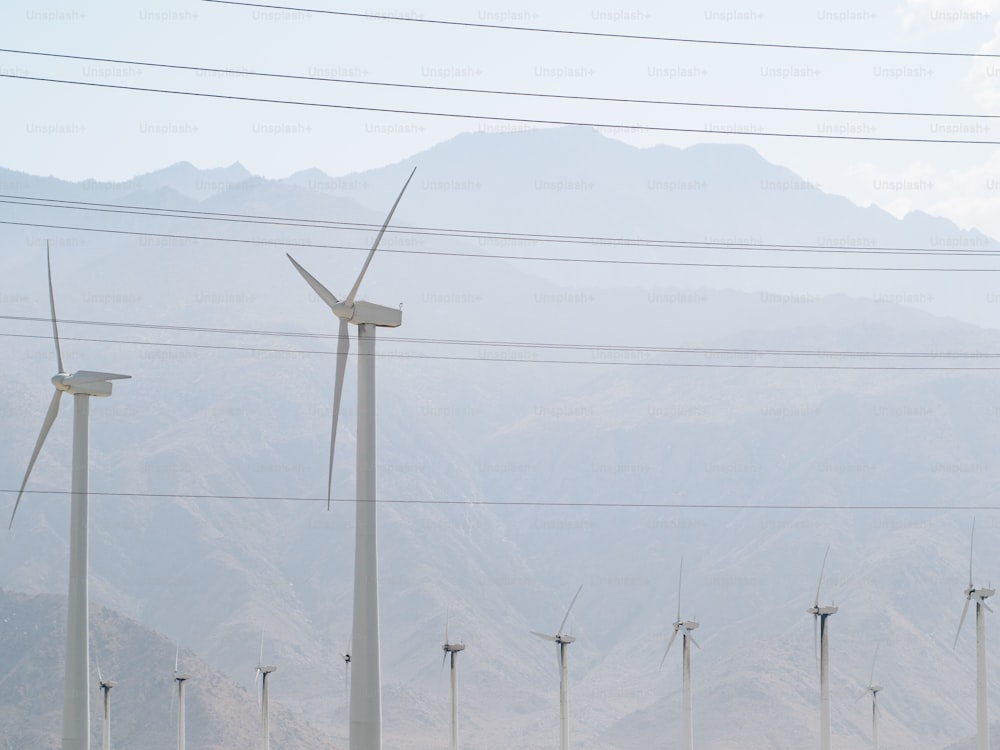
7;74;1000;146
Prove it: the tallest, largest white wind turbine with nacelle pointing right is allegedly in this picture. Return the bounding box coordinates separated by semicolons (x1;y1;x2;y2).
288;169;416;750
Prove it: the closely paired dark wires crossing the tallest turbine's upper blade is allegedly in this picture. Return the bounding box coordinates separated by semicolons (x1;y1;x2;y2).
0;194;1000;257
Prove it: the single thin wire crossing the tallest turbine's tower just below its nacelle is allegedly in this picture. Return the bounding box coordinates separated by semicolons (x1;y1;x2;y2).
0;332;1000;372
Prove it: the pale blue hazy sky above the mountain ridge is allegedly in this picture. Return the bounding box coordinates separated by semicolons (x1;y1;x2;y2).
0;0;1000;236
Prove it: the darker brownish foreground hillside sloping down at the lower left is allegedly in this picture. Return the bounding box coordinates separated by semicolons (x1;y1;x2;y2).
0;590;331;750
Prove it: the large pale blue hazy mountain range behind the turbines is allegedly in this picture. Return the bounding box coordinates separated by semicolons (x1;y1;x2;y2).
0;129;1000;749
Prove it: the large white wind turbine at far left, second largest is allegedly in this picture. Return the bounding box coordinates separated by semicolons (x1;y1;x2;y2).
8;243;131;750
